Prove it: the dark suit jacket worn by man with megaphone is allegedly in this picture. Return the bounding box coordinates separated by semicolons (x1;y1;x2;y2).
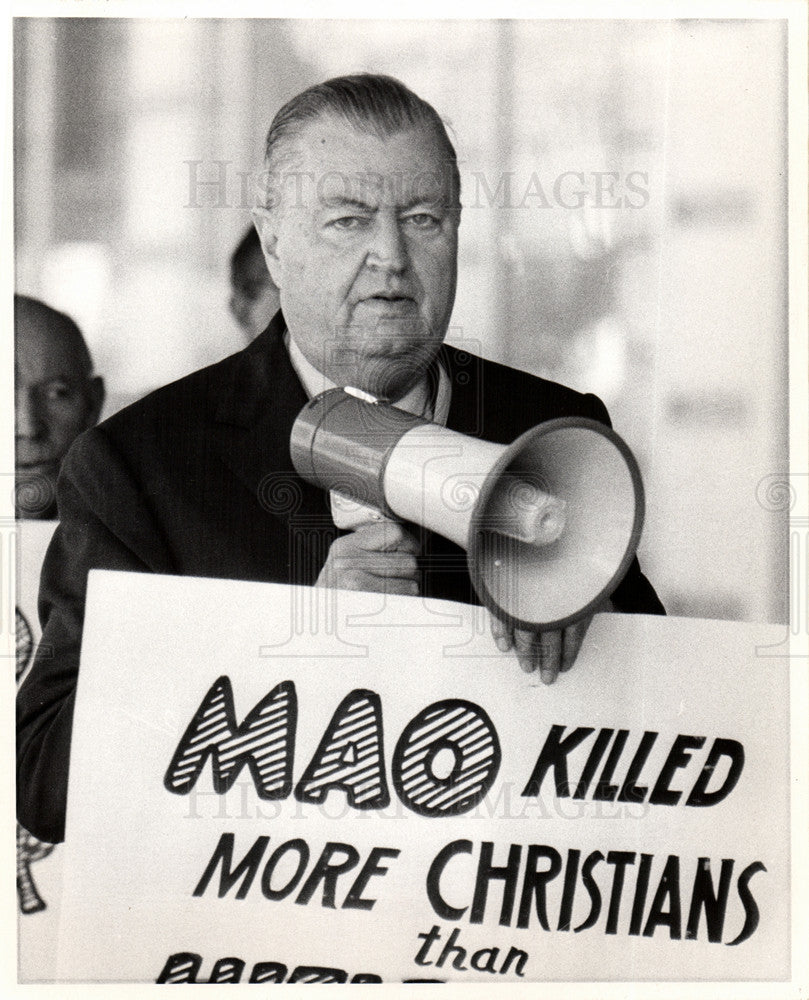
17;313;663;841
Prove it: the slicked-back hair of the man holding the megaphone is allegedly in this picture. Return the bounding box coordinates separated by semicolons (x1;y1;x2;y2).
264;73;461;199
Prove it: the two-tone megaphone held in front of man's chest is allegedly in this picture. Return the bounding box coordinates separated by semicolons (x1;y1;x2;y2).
290;389;644;631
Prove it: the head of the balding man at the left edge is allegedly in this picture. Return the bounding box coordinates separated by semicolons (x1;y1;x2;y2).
14;295;104;518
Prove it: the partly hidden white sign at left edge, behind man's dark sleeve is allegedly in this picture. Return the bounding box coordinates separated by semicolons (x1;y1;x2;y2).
15;521;63;982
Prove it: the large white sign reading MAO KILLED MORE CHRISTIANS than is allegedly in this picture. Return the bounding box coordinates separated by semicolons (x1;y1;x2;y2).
58;572;790;983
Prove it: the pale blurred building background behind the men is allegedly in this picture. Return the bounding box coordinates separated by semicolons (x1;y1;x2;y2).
14;18;788;622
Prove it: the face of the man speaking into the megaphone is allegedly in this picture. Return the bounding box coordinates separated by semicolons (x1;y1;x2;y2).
259;116;460;401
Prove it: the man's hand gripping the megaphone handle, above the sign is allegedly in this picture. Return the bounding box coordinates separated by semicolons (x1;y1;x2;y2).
316;521;419;597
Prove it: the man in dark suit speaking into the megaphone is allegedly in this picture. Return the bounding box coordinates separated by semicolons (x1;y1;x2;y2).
18;76;662;840
